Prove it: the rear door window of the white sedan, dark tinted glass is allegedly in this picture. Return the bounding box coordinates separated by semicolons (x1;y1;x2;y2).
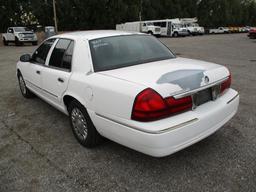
49;39;74;70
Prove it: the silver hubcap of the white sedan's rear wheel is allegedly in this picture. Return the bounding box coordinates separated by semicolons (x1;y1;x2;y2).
71;108;88;141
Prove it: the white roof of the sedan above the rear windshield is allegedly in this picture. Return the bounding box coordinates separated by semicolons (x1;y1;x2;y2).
54;30;141;40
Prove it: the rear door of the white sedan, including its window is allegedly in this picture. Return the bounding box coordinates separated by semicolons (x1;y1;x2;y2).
42;39;74;105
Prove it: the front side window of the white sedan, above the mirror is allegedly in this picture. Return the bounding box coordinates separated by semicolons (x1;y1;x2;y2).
32;39;56;65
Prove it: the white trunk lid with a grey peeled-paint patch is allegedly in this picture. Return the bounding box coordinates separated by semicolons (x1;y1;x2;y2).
99;57;229;97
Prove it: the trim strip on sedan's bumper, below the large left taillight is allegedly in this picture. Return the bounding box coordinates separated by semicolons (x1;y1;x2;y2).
95;113;198;134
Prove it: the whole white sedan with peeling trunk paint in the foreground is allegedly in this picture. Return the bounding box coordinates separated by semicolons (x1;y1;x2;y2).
17;31;239;157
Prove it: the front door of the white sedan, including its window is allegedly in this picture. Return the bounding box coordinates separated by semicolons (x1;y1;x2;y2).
22;39;56;93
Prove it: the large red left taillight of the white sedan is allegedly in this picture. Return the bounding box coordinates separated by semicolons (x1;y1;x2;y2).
131;88;192;122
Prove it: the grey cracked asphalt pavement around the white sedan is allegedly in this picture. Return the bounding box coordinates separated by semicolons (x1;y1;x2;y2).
0;34;256;192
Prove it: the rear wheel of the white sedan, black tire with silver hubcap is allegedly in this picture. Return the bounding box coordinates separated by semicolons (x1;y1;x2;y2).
68;100;102;148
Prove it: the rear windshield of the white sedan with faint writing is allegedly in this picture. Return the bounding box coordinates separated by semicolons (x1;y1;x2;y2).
89;35;175;72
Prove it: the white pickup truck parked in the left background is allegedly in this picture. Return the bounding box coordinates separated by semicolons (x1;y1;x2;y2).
2;27;37;46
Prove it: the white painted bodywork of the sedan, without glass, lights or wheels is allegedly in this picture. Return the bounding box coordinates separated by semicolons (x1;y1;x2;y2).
17;31;239;157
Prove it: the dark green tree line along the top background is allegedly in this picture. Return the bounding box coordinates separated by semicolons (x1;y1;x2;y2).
0;0;256;32
